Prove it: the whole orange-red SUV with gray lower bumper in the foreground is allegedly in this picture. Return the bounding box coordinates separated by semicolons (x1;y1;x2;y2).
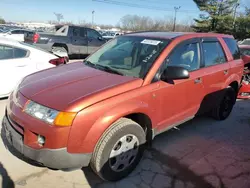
2;32;244;181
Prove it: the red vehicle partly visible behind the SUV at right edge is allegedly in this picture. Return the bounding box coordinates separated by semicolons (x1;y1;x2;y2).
238;45;250;99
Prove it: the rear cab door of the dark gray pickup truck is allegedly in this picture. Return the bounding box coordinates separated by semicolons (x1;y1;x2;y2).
71;27;88;54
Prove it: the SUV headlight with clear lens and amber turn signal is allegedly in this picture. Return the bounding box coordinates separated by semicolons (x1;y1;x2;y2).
24;101;76;126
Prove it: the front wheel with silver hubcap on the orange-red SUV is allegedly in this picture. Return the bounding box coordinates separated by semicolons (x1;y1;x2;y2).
90;118;146;181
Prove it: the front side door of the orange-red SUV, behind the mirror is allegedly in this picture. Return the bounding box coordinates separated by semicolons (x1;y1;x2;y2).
157;39;204;130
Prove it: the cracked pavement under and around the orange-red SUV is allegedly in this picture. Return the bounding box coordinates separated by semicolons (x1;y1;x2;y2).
0;100;250;188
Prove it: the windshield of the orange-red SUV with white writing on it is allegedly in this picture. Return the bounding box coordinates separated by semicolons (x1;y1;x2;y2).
86;36;169;78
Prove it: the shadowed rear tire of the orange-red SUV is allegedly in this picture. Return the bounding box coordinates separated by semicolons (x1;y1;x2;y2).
212;87;236;120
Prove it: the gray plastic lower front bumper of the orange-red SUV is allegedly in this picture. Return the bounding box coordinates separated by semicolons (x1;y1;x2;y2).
2;116;92;170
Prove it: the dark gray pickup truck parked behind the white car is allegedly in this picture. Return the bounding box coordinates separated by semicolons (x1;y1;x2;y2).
24;25;106;55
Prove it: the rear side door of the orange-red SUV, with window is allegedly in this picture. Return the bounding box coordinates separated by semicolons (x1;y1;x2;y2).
197;38;230;110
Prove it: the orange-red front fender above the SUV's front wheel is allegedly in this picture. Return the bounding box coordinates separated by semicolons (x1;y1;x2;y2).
68;84;159;153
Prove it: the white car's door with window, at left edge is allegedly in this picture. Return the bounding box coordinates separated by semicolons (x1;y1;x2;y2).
0;44;32;95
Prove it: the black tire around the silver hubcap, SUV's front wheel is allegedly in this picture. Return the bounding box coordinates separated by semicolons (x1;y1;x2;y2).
90;118;146;181
